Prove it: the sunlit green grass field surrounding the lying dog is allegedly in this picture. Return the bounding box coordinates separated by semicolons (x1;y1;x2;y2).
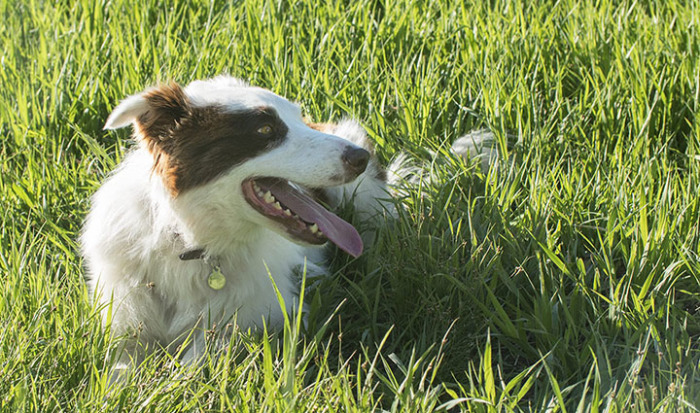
0;0;700;412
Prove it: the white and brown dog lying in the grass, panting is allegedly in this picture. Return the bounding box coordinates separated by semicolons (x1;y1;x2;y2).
81;76;394;368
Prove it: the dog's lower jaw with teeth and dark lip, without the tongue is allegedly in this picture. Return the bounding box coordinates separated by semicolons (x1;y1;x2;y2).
241;178;328;246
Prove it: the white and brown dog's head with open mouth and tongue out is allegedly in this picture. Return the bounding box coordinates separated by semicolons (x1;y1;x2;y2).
105;77;369;256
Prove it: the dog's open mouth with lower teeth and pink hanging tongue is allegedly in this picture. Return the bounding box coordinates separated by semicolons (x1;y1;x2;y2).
242;178;363;257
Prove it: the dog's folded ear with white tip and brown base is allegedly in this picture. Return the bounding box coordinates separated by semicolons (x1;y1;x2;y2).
104;83;191;139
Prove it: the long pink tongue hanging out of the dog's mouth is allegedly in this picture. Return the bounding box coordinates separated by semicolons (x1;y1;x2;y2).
269;180;362;257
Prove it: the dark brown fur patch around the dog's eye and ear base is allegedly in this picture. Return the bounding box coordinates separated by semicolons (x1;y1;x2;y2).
136;83;288;197
